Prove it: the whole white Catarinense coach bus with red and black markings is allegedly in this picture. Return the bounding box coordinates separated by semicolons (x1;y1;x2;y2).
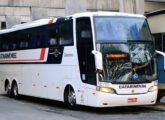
0;12;158;108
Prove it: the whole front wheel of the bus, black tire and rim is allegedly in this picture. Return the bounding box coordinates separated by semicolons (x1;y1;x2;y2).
64;86;77;110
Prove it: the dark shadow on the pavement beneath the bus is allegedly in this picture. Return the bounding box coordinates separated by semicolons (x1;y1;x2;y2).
5;96;165;115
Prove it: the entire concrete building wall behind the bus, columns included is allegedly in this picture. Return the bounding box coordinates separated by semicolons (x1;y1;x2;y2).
0;0;144;27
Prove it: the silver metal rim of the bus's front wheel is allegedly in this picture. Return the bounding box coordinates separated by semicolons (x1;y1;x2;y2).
68;87;76;106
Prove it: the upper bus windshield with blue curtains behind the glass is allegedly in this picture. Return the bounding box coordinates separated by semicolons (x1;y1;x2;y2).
94;16;152;42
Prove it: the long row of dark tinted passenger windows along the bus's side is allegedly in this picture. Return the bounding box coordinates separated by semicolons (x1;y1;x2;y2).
0;21;73;51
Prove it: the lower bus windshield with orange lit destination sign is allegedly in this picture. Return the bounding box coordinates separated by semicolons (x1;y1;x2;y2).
97;43;157;83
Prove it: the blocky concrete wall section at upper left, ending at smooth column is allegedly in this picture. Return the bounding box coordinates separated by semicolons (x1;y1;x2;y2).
0;0;66;28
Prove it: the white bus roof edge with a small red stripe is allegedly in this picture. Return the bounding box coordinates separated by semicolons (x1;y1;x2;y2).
0;12;145;34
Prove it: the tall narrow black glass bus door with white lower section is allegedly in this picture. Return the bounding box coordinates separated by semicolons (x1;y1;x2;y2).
76;17;96;104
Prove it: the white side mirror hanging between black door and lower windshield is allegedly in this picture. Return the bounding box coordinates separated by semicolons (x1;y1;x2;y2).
92;50;103;70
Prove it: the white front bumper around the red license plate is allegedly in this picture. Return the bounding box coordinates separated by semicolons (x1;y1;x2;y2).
88;91;158;107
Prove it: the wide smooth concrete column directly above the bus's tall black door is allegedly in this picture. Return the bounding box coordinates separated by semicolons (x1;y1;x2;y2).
65;0;87;16
